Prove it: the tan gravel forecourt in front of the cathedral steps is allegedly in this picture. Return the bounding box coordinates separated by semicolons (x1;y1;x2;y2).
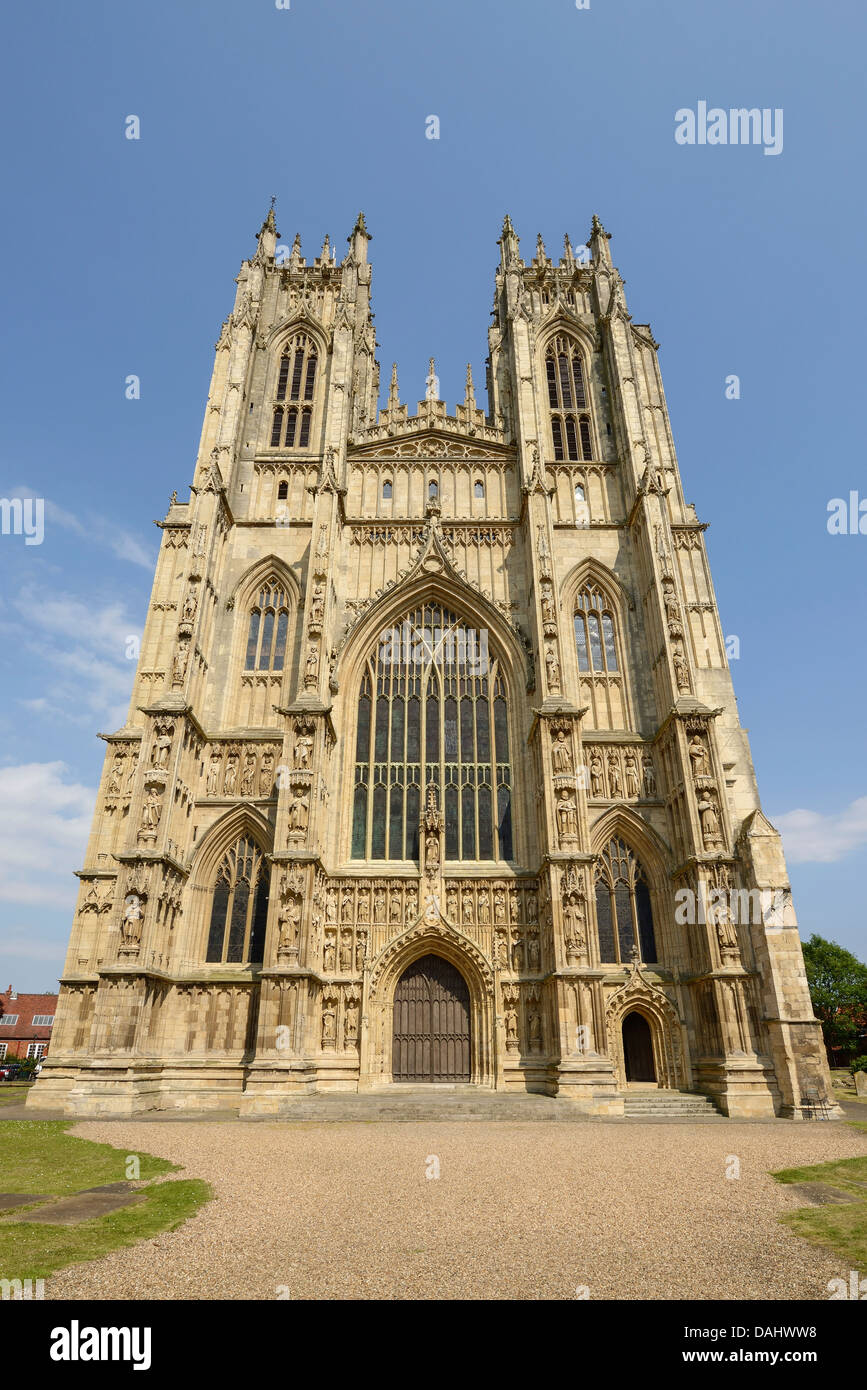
46;1120;867;1300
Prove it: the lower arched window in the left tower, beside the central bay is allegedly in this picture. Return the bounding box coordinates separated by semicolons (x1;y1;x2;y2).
206;838;268;965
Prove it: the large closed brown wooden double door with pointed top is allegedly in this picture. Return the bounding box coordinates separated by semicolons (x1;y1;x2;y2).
392;955;470;1083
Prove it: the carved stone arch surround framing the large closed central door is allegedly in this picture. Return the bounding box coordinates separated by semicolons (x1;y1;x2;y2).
361;915;496;1087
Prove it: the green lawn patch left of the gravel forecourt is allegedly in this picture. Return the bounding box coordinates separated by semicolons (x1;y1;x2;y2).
0;1120;213;1279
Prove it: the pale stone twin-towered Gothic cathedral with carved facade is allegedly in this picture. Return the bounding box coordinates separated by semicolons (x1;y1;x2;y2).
28;211;829;1118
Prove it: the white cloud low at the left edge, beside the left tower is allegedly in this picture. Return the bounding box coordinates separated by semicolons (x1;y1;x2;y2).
0;762;96;906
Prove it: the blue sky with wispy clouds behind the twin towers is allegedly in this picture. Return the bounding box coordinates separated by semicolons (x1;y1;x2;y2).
0;0;867;990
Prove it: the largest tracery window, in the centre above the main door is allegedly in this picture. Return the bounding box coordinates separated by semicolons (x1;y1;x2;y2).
352;603;514;860
